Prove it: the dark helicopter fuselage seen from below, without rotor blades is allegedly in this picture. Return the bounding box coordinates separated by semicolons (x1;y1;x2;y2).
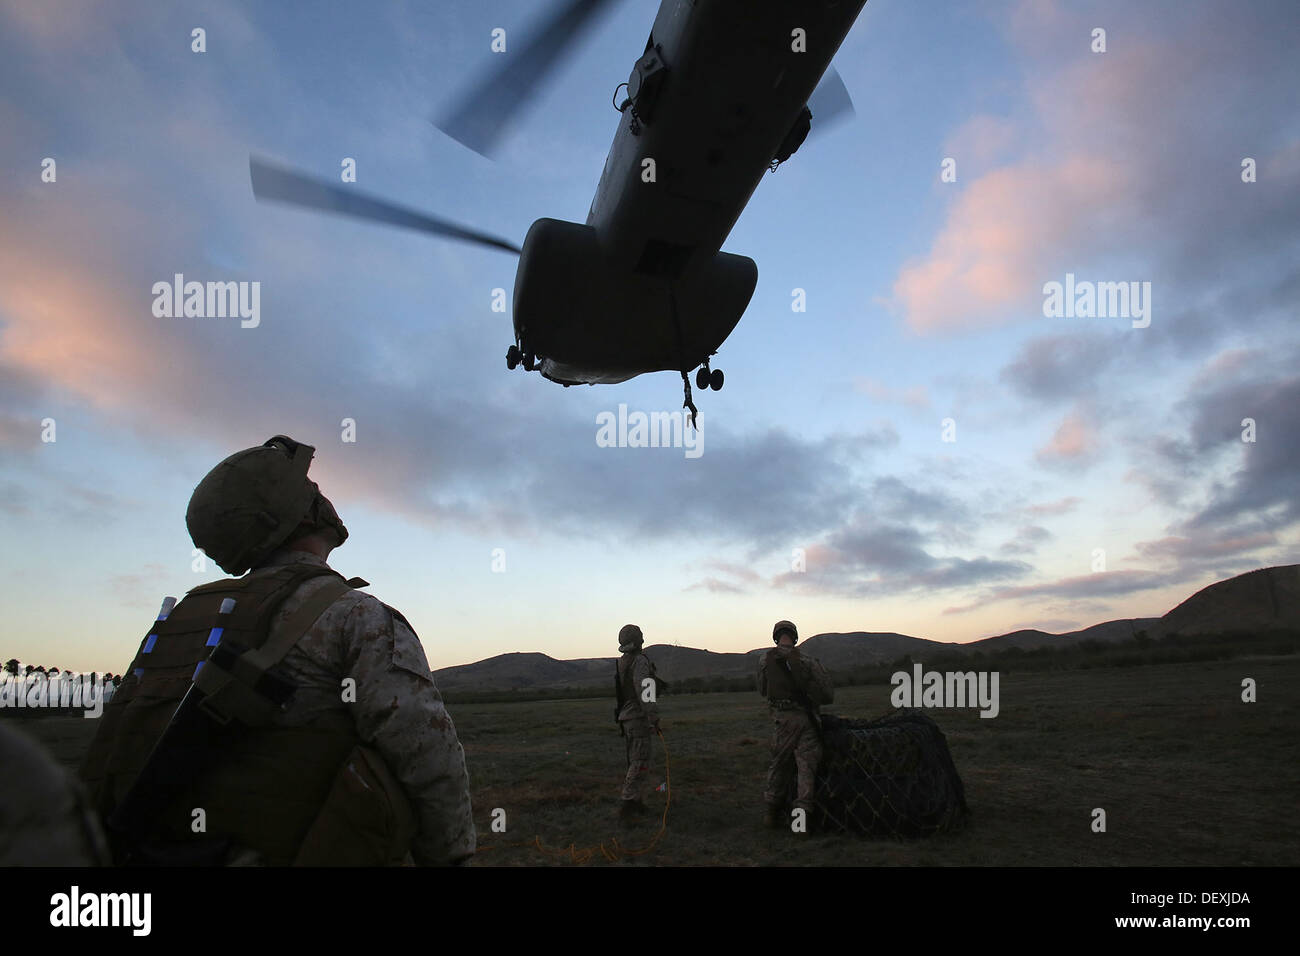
514;0;866;385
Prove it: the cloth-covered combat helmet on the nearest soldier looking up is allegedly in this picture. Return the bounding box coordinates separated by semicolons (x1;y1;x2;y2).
185;434;347;575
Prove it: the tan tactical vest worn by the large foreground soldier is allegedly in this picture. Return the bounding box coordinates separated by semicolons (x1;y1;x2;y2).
82;564;415;865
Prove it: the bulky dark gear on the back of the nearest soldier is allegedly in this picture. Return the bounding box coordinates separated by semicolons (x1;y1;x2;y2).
82;564;403;864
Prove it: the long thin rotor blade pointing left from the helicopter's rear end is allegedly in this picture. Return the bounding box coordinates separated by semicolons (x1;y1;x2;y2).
248;156;519;255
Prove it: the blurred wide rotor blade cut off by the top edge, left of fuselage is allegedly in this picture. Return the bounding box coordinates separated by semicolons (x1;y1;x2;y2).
434;0;616;156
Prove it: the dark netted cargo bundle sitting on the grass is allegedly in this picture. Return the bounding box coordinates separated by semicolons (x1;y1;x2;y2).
810;709;969;836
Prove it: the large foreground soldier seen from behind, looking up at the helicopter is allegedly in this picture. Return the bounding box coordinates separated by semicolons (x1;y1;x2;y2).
82;436;475;865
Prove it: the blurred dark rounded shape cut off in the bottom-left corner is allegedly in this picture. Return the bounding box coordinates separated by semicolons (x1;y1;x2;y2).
0;726;108;866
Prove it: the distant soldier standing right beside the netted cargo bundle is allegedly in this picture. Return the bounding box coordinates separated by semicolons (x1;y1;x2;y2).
758;620;835;827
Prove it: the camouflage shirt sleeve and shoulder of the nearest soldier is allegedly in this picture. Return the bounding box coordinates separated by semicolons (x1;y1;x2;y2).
250;550;476;865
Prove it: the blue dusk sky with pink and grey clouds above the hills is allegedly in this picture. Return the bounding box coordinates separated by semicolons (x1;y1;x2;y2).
0;0;1300;672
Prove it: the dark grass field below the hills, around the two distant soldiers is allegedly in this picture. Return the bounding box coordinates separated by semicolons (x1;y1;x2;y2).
10;656;1300;866
